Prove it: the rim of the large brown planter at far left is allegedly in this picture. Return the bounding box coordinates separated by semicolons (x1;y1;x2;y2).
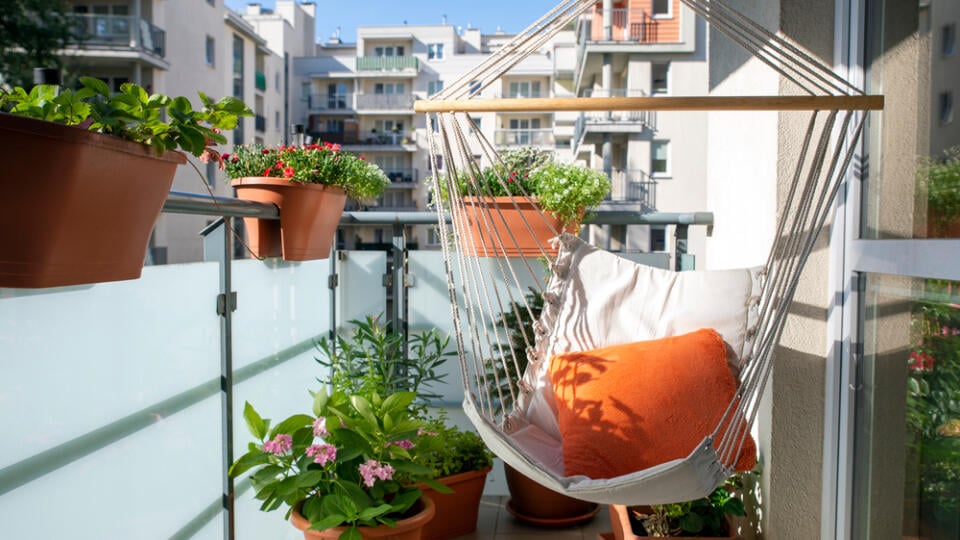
0;112;187;165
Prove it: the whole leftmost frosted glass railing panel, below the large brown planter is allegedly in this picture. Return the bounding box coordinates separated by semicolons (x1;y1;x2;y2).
0;264;222;538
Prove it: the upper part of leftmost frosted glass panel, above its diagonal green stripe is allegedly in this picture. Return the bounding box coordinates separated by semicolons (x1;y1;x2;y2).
0;264;220;468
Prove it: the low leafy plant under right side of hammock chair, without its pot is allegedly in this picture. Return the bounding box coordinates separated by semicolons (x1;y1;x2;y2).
628;473;746;537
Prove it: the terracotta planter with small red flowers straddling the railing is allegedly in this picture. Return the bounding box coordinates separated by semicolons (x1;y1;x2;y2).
221;143;390;261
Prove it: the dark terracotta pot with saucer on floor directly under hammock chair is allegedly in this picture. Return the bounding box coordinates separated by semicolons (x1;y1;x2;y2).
503;463;600;527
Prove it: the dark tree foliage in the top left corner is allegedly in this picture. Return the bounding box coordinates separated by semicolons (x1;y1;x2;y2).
0;0;80;87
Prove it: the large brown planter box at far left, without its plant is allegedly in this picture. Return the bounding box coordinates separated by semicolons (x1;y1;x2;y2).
0;113;186;288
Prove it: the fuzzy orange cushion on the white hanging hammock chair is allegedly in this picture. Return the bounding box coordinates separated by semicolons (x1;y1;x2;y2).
549;328;756;478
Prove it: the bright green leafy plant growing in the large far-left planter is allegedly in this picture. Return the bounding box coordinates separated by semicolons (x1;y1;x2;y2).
0;77;253;159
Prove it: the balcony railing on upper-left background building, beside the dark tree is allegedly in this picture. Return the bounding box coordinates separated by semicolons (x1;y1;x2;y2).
70;13;166;58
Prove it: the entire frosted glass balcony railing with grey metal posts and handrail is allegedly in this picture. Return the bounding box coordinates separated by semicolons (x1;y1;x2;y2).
0;188;712;539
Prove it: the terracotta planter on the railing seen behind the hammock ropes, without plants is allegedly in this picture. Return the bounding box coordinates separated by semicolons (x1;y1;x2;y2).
456;197;580;257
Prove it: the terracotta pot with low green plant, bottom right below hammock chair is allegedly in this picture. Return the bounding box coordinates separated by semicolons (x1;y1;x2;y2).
610;473;746;540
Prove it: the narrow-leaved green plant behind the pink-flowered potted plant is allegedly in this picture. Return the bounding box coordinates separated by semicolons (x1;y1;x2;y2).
315;315;456;417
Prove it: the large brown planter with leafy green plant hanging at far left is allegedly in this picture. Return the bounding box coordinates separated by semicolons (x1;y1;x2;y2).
0;77;252;287
